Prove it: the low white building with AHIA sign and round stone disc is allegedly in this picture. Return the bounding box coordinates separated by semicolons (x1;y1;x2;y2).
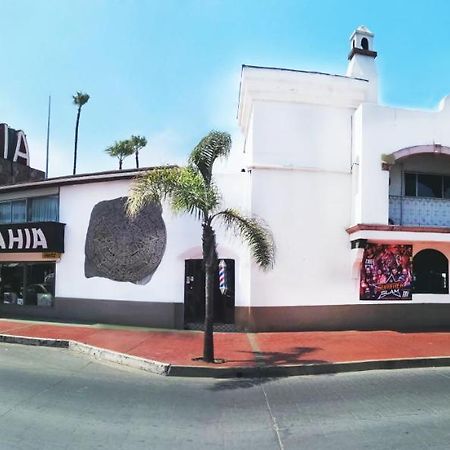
0;169;246;328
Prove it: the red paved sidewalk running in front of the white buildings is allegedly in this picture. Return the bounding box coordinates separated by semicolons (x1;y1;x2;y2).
0;319;450;376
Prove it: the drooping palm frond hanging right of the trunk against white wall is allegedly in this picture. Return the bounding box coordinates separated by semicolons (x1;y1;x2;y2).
213;209;275;269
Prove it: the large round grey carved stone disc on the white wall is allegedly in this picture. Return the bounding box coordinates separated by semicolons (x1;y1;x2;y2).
84;197;166;284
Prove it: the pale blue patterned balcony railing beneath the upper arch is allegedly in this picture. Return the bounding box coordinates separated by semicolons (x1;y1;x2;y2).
389;195;450;227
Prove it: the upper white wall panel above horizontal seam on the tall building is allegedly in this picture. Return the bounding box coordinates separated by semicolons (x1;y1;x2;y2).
252;101;353;173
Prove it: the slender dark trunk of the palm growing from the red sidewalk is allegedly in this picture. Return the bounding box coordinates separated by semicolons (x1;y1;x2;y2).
203;224;217;362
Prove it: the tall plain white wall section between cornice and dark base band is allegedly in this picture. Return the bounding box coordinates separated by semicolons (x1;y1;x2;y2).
244;97;356;307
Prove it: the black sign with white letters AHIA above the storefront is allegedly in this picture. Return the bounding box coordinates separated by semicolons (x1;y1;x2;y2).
0;222;65;253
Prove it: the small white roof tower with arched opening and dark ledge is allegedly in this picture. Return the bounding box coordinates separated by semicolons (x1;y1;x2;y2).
346;26;378;102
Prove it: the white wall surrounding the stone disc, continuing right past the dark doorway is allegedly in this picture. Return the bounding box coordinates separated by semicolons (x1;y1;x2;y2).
56;173;249;306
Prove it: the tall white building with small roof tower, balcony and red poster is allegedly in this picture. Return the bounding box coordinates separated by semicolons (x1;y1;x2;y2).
239;27;450;329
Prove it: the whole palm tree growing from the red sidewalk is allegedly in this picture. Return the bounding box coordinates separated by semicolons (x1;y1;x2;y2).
127;131;275;362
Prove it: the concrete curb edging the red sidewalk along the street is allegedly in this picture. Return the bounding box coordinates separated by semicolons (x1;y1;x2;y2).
0;334;450;378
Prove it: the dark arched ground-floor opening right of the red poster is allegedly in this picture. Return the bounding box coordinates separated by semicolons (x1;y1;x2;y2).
413;249;448;294
